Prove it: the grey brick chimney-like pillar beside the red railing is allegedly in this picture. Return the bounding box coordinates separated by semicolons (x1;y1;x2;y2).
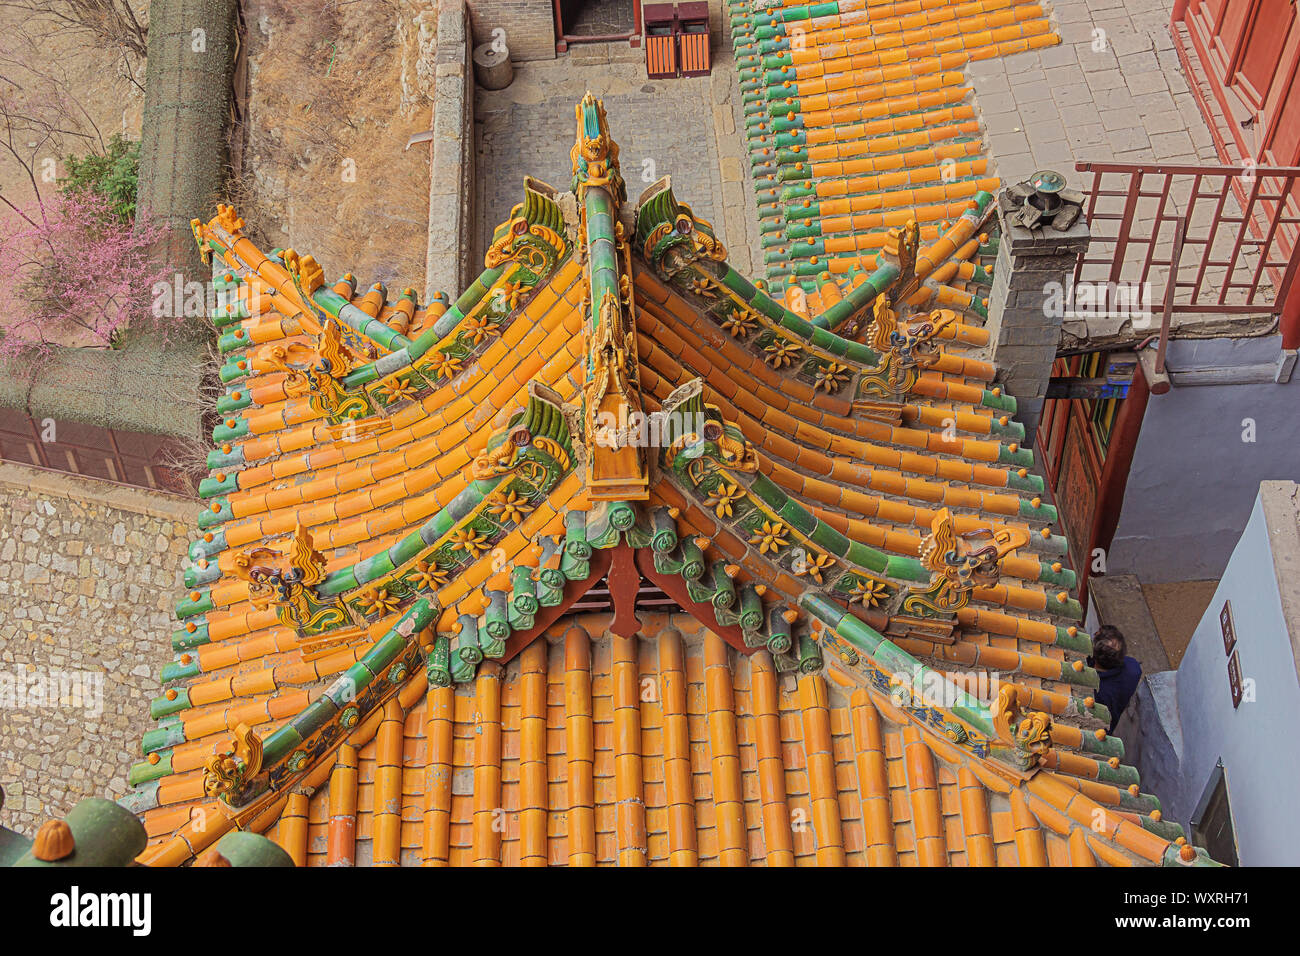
987;190;1092;447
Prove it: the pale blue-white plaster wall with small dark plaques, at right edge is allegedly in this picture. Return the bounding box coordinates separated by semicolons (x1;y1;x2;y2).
1171;497;1300;866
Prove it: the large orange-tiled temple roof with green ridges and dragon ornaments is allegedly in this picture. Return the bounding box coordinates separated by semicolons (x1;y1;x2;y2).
114;95;1205;865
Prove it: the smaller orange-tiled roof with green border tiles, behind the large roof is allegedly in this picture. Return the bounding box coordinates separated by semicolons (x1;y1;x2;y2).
729;0;1060;316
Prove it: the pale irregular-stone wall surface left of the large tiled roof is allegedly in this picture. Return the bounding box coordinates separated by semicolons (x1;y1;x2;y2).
0;463;198;835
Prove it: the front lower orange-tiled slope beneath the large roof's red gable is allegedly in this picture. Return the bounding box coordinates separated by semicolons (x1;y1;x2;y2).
244;614;1190;866
